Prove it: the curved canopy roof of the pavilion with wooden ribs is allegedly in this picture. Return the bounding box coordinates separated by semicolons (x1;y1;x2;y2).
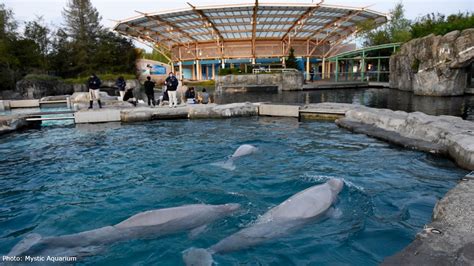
114;1;387;47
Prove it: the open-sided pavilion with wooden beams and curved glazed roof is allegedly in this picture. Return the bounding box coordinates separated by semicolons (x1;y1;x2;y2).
114;0;387;80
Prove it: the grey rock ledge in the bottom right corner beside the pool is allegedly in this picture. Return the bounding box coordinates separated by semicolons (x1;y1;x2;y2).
382;178;474;266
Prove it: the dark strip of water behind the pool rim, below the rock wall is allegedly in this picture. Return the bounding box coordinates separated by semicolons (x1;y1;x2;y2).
214;88;474;120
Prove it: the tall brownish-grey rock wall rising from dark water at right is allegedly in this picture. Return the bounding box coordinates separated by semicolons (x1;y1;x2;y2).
390;29;474;96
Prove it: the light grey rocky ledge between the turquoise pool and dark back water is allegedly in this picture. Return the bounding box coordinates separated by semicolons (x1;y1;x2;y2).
336;104;474;170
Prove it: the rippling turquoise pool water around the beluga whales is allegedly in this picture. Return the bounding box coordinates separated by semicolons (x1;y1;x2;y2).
0;117;466;265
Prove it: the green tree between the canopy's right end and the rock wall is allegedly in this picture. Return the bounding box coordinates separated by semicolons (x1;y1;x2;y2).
357;2;411;46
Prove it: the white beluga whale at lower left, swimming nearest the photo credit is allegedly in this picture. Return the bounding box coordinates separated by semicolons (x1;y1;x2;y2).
8;203;240;257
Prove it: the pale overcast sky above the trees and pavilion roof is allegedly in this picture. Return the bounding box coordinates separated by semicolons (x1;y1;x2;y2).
0;0;474;50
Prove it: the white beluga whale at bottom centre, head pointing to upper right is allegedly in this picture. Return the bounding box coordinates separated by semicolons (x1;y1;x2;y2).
183;179;344;266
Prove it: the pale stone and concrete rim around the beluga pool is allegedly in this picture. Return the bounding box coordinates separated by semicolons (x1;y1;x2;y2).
0;102;474;265
